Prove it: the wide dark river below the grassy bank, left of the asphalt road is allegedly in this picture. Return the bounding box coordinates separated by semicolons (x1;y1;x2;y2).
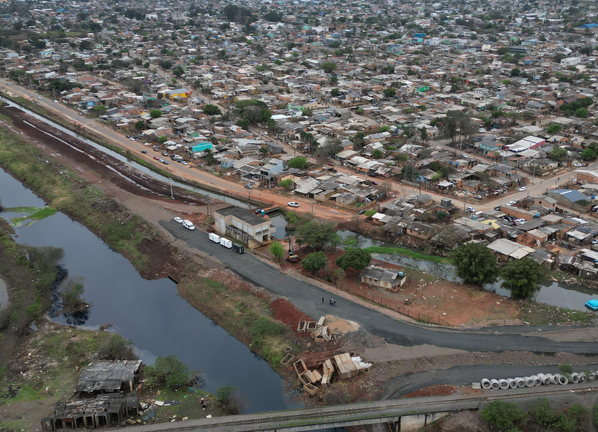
0;170;303;413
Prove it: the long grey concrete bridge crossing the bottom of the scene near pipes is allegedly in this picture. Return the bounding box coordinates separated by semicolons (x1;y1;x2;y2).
116;383;598;432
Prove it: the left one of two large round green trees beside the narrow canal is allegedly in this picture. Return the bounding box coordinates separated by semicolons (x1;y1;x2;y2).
451;243;499;285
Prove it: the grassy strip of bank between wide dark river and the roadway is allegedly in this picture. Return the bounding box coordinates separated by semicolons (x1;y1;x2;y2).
0;109;360;412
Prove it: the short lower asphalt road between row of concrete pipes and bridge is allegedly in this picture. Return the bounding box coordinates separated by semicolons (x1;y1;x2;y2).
380;365;598;399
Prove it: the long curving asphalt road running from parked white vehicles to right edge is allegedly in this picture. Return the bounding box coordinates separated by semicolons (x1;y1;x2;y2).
161;221;598;354
